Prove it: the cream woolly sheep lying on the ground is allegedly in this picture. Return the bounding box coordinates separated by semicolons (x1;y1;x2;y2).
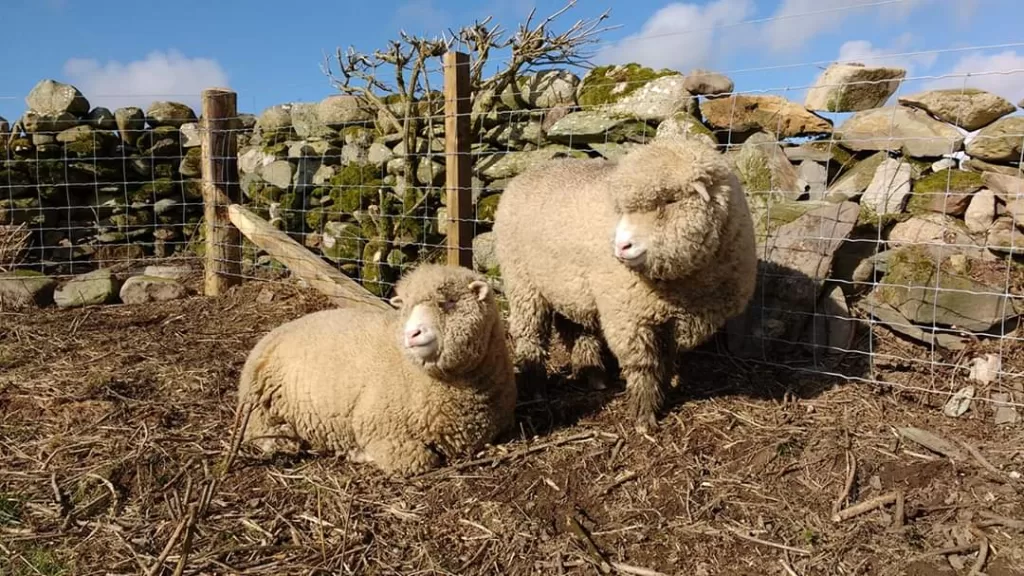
239;264;516;476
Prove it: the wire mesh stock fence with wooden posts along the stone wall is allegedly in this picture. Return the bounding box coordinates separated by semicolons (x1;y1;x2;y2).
0;49;1024;421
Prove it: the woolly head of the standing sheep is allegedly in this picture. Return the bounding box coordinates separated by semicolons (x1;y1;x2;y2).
608;140;734;280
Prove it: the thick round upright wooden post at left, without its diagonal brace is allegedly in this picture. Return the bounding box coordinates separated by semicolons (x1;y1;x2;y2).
201;88;242;296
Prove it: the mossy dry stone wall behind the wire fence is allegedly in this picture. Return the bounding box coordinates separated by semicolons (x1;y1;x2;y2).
0;64;1024;355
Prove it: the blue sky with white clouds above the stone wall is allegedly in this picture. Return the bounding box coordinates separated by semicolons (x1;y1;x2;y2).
0;0;1024;122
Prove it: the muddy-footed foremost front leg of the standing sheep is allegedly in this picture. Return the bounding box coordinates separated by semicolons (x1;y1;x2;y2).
602;314;666;434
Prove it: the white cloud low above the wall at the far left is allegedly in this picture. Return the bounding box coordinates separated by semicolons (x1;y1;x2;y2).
63;49;227;115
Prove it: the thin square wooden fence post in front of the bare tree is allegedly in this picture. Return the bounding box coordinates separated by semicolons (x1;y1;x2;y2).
444;51;473;269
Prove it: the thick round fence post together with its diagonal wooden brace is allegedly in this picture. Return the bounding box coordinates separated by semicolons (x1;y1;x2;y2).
203;88;391;310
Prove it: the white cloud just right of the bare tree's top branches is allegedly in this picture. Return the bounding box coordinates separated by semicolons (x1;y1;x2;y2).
594;0;755;72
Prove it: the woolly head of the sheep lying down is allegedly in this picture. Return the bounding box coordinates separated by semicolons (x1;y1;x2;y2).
391;270;497;374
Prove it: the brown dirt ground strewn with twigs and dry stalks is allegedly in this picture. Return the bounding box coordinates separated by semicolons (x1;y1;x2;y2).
0;264;1024;576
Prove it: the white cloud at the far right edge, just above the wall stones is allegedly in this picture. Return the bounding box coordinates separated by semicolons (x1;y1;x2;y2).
924;50;1024;104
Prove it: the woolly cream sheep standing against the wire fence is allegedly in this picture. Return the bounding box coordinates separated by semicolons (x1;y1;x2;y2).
494;137;757;431
